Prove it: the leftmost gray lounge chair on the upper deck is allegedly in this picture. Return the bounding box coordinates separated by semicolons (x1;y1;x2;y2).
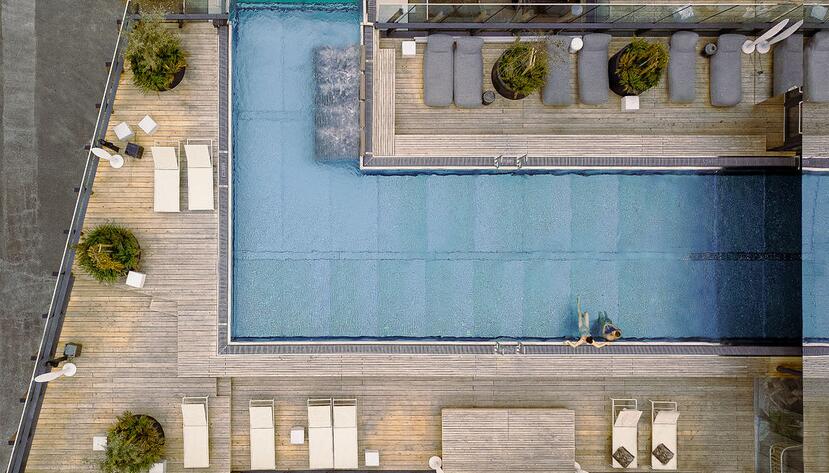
423;34;455;107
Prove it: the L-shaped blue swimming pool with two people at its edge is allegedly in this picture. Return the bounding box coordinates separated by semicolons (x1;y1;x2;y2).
231;5;802;342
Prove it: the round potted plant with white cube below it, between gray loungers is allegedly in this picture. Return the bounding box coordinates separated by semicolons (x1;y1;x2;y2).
608;38;668;97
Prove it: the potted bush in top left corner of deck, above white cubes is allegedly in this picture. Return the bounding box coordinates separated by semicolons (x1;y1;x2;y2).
124;15;187;92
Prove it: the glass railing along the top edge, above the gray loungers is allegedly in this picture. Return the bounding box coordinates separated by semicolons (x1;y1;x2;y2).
377;0;804;24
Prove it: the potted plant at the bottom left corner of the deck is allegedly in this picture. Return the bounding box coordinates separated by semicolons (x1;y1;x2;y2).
100;411;164;473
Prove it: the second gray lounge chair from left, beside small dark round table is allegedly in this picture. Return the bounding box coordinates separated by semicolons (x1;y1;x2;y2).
455;37;484;108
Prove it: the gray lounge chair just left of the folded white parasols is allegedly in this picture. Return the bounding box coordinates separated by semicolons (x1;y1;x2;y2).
709;34;746;107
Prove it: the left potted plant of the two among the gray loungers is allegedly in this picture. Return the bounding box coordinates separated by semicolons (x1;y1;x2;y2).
491;38;548;100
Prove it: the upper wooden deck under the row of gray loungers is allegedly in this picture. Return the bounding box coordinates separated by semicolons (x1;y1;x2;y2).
374;38;789;159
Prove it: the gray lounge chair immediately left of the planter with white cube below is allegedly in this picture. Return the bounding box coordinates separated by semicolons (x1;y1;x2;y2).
579;33;610;105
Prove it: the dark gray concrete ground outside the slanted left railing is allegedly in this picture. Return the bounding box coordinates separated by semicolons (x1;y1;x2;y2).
0;0;124;464
